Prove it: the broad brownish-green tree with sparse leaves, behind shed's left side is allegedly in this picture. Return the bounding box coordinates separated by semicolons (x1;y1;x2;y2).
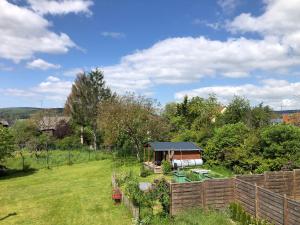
98;94;169;160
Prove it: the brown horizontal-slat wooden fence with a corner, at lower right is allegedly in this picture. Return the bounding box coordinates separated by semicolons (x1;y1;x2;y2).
170;170;300;225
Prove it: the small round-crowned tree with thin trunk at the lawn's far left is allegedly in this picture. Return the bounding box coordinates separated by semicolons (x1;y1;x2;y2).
12;120;39;170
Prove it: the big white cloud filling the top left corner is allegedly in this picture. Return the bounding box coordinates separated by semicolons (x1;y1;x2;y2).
0;0;76;62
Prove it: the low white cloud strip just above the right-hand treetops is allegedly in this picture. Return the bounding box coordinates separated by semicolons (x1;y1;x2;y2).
175;79;300;110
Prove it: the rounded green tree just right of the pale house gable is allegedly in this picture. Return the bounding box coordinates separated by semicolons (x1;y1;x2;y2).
221;96;251;124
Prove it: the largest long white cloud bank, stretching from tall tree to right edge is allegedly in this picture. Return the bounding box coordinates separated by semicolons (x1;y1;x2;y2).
103;37;300;90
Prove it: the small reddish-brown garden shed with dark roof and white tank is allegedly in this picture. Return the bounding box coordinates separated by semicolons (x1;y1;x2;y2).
144;142;203;172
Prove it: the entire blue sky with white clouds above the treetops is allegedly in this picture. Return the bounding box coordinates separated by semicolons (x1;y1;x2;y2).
0;0;300;110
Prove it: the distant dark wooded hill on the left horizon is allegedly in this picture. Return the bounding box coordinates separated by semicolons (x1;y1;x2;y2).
0;107;63;124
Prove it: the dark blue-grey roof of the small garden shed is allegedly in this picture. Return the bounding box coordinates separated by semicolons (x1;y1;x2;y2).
149;142;203;151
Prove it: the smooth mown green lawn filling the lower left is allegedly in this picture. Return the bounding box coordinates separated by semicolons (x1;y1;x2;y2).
0;160;132;225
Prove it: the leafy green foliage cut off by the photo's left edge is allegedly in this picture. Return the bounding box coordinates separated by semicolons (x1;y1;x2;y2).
0;126;15;162
